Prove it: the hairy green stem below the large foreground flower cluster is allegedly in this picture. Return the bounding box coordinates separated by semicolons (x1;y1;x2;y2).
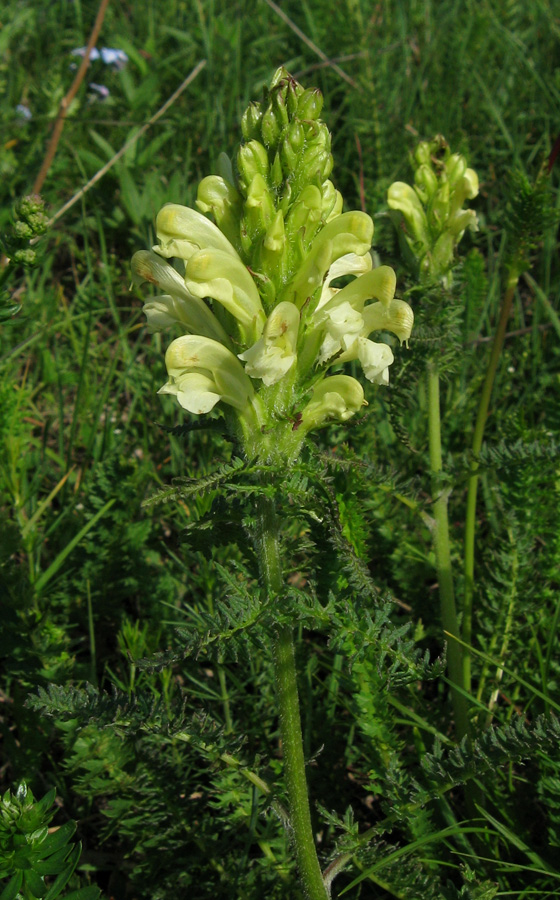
258;497;329;900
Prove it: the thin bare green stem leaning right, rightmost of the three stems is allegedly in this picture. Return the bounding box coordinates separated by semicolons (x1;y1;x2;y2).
461;274;519;692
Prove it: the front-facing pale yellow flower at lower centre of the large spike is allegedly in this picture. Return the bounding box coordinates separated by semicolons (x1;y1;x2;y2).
238;301;299;385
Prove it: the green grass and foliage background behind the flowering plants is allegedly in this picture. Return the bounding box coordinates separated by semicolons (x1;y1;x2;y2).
0;0;560;900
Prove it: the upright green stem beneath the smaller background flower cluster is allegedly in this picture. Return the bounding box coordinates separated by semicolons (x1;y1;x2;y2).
428;360;470;740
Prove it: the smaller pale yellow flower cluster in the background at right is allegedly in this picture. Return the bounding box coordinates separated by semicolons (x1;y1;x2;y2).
387;135;478;281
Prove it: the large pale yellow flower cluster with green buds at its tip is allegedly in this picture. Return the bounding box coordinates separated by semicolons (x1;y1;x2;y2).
132;69;413;458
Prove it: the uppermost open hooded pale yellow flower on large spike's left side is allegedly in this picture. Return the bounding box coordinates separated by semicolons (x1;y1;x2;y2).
153;203;239;260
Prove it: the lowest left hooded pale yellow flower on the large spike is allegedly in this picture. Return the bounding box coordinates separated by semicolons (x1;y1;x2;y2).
158;334;254;415
